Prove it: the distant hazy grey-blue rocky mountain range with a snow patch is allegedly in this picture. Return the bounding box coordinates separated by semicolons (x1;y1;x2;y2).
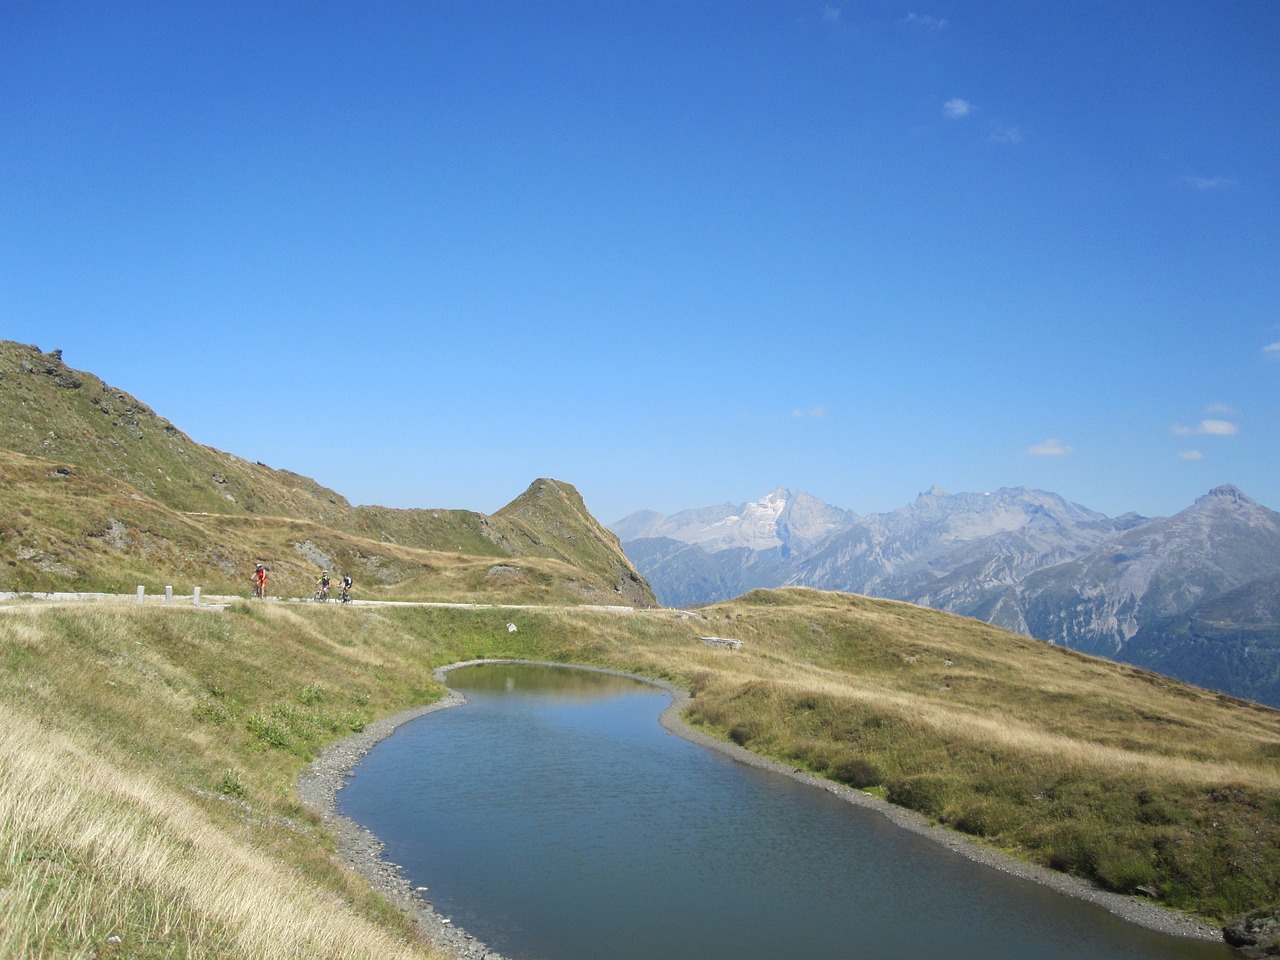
609;485;1280;707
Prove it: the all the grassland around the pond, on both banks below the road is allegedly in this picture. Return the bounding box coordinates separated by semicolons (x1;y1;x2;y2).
0;590;1280;959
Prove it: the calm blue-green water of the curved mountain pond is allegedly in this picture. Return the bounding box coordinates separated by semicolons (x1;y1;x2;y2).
339;664;1234;960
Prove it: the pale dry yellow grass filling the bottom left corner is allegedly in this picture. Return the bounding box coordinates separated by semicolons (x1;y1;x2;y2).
0;707;445;960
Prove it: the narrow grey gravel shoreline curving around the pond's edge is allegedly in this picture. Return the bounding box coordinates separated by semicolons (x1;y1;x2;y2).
298;660;1222;960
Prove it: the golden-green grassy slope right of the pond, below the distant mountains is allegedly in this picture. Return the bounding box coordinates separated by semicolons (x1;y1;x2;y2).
692;590;1280;919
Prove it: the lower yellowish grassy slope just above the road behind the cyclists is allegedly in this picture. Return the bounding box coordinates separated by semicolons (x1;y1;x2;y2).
0;449;643;604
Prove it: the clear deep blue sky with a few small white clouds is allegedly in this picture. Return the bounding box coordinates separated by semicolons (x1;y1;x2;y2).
0;0;1280;522
